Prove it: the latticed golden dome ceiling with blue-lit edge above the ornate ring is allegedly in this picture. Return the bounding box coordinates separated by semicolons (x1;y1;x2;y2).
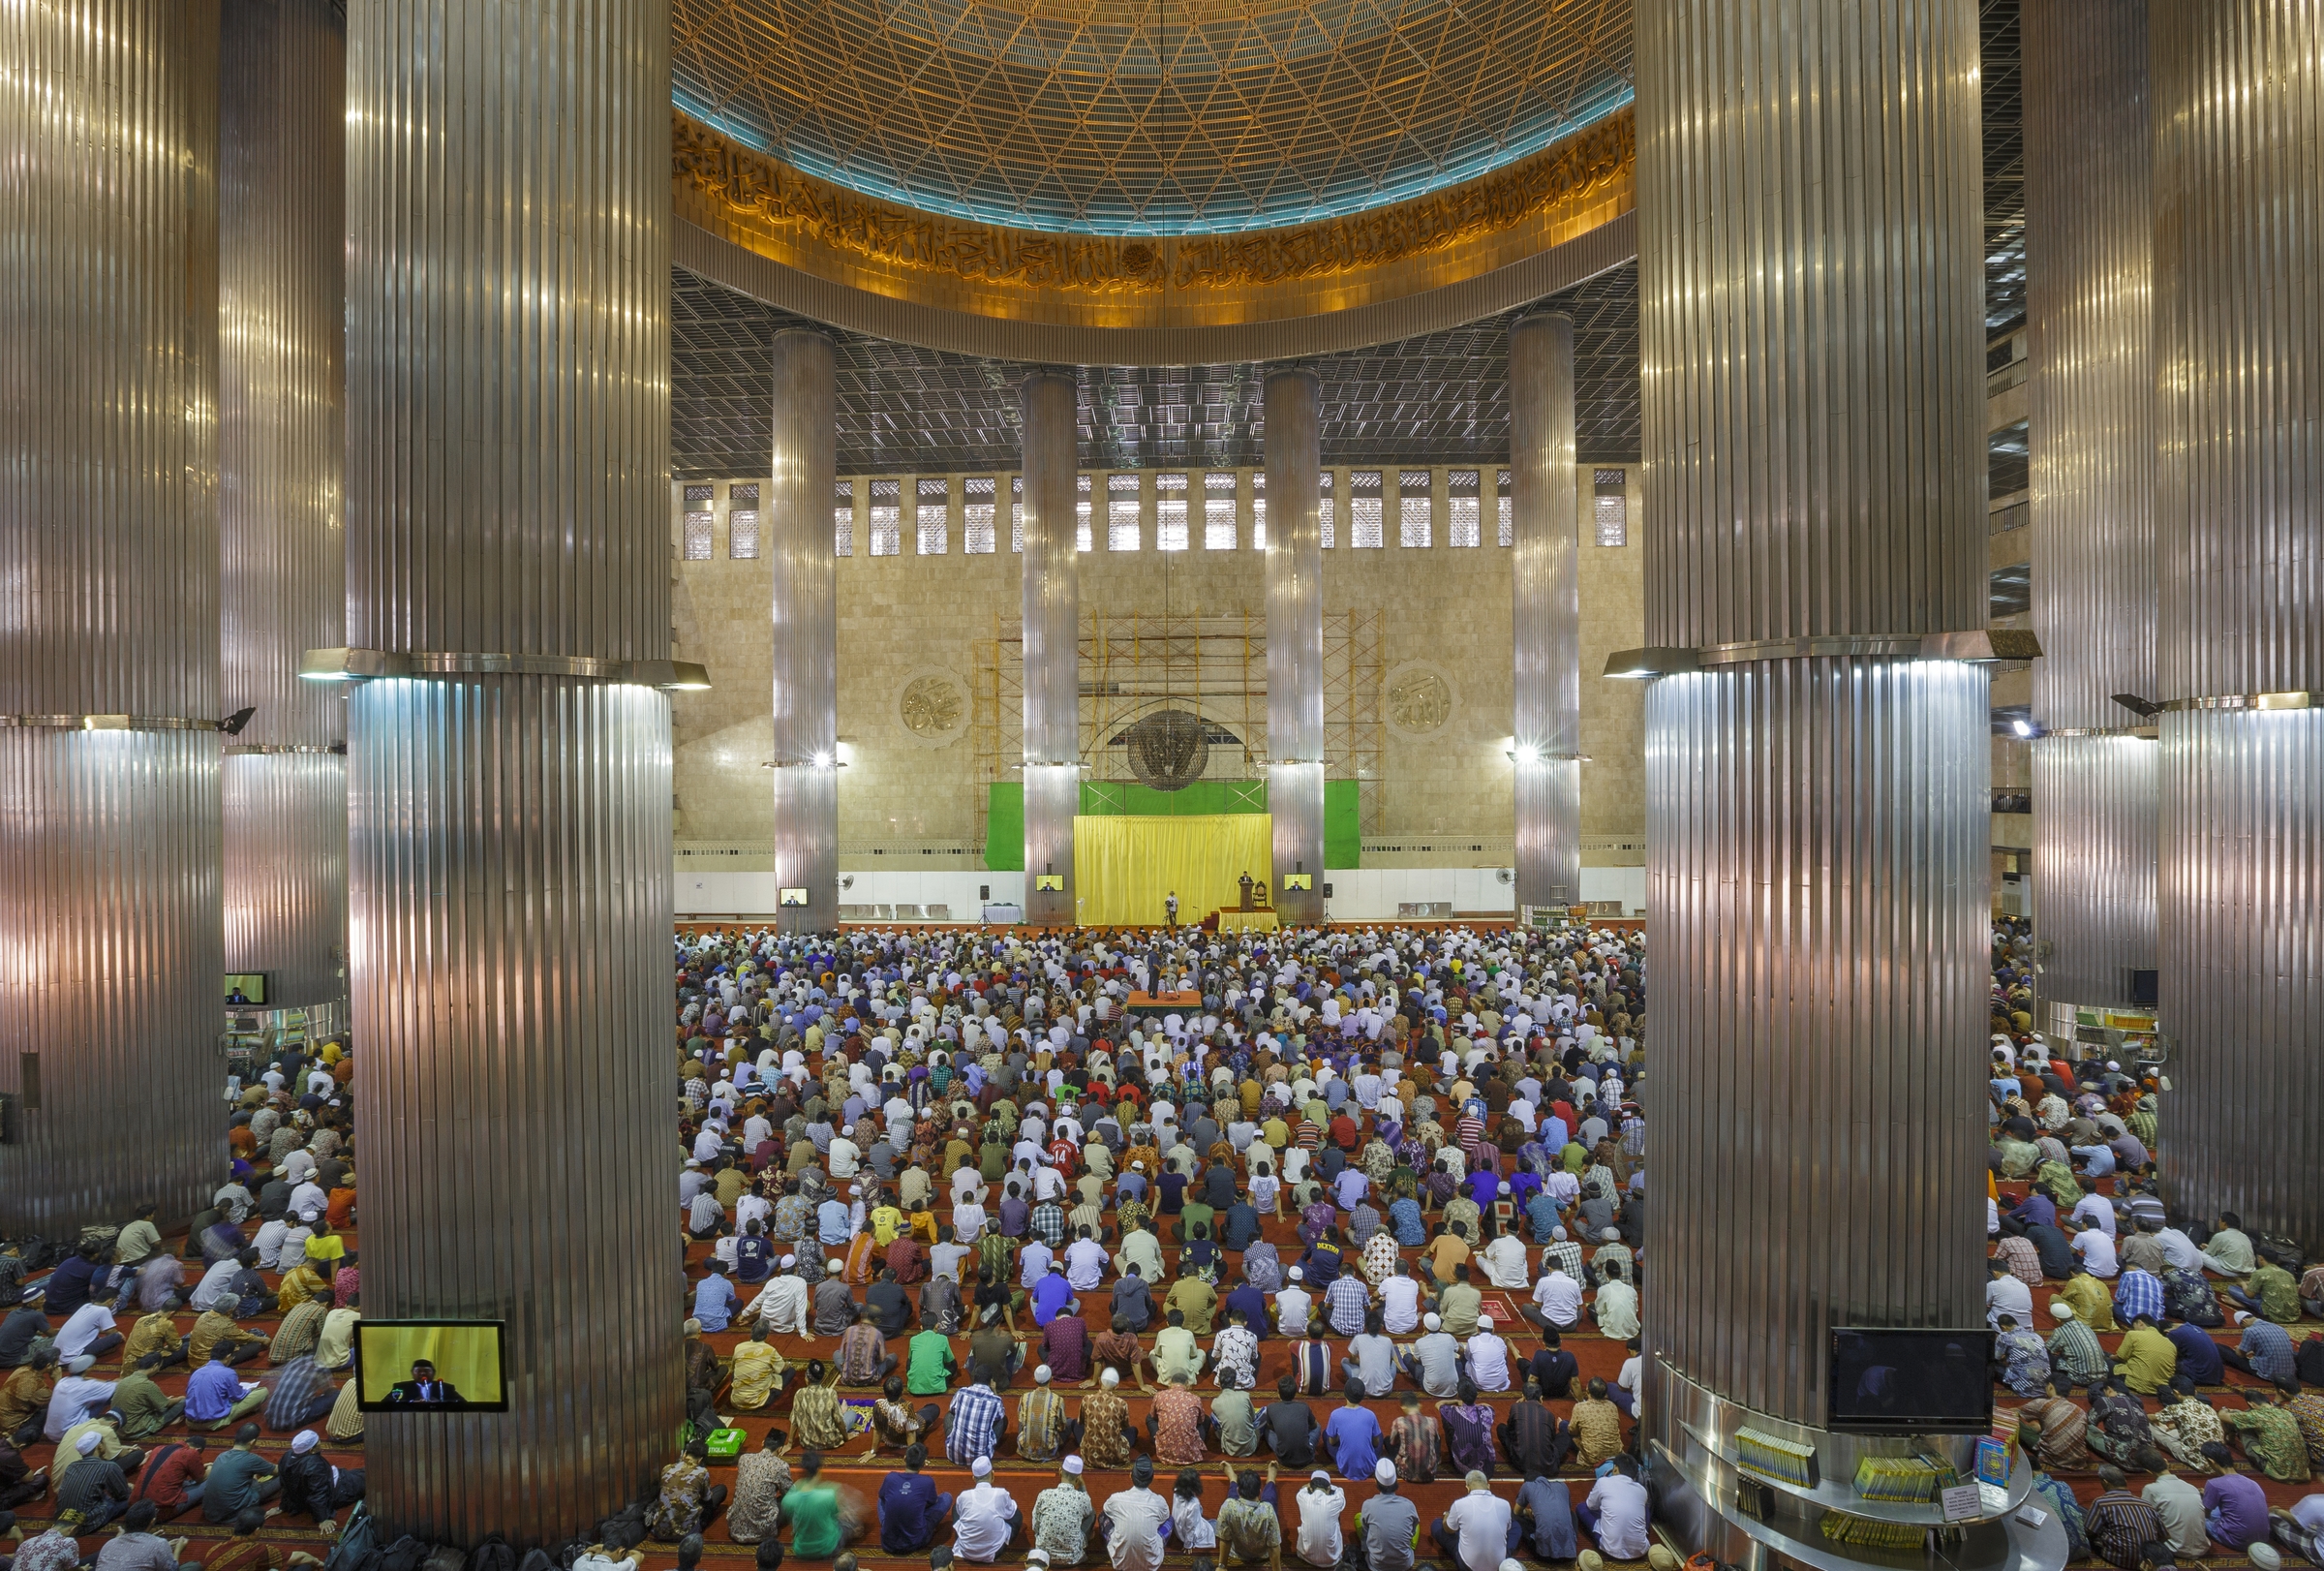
674;0;1629;234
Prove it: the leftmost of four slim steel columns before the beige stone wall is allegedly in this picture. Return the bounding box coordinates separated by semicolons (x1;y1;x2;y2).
767;330;839;932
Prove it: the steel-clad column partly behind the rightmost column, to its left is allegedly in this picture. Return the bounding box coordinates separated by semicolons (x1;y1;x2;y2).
2024;0;2156;1041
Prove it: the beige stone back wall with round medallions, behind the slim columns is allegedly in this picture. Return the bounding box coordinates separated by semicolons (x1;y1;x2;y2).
672;465;1645;872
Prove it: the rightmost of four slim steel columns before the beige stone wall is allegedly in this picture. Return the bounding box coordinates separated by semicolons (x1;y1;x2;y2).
1509;312;1582;911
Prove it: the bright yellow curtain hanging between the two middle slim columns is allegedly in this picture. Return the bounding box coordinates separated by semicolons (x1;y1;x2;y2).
1074;814;1276;927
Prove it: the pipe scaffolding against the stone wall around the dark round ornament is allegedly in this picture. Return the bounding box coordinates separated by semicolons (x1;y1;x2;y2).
969;609;1388;844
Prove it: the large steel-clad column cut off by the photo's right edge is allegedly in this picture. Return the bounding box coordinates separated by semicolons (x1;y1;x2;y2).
2152;0;2324;1250
